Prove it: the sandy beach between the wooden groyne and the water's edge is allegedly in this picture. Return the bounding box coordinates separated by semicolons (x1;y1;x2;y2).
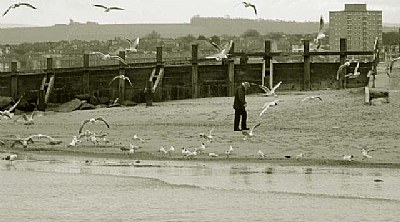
0;88;400;168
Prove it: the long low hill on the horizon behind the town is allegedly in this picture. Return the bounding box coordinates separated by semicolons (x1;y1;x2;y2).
0;16;397;44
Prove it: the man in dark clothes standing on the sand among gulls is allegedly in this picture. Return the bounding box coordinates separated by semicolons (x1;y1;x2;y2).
233;82;250;131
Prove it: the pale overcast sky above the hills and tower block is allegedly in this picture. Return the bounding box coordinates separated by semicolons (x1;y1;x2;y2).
0;0;400;26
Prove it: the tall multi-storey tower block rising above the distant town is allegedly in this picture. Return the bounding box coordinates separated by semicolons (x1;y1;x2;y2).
329;4;382;51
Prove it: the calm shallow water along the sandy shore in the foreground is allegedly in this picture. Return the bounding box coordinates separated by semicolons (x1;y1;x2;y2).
0;158;400;221
